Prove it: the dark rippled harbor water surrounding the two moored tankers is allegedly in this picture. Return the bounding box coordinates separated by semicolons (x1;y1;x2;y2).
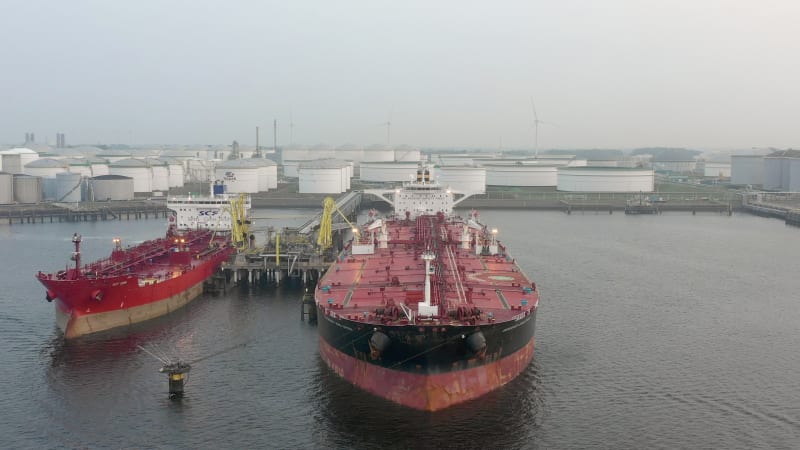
0;210;800;449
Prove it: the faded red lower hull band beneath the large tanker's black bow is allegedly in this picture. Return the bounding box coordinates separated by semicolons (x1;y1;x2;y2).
319;338;535;411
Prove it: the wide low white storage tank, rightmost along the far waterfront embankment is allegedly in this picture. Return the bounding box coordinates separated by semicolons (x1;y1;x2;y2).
558;167;655;192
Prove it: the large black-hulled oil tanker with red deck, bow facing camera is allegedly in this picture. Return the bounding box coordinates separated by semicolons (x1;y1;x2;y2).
315;166;539;411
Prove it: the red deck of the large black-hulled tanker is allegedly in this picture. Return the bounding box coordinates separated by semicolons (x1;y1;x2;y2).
317;217;538;321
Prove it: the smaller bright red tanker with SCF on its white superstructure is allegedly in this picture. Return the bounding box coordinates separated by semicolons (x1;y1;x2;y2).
36;183;250;339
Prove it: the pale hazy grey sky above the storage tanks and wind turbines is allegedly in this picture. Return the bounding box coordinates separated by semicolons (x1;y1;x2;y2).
0;0;800;149
